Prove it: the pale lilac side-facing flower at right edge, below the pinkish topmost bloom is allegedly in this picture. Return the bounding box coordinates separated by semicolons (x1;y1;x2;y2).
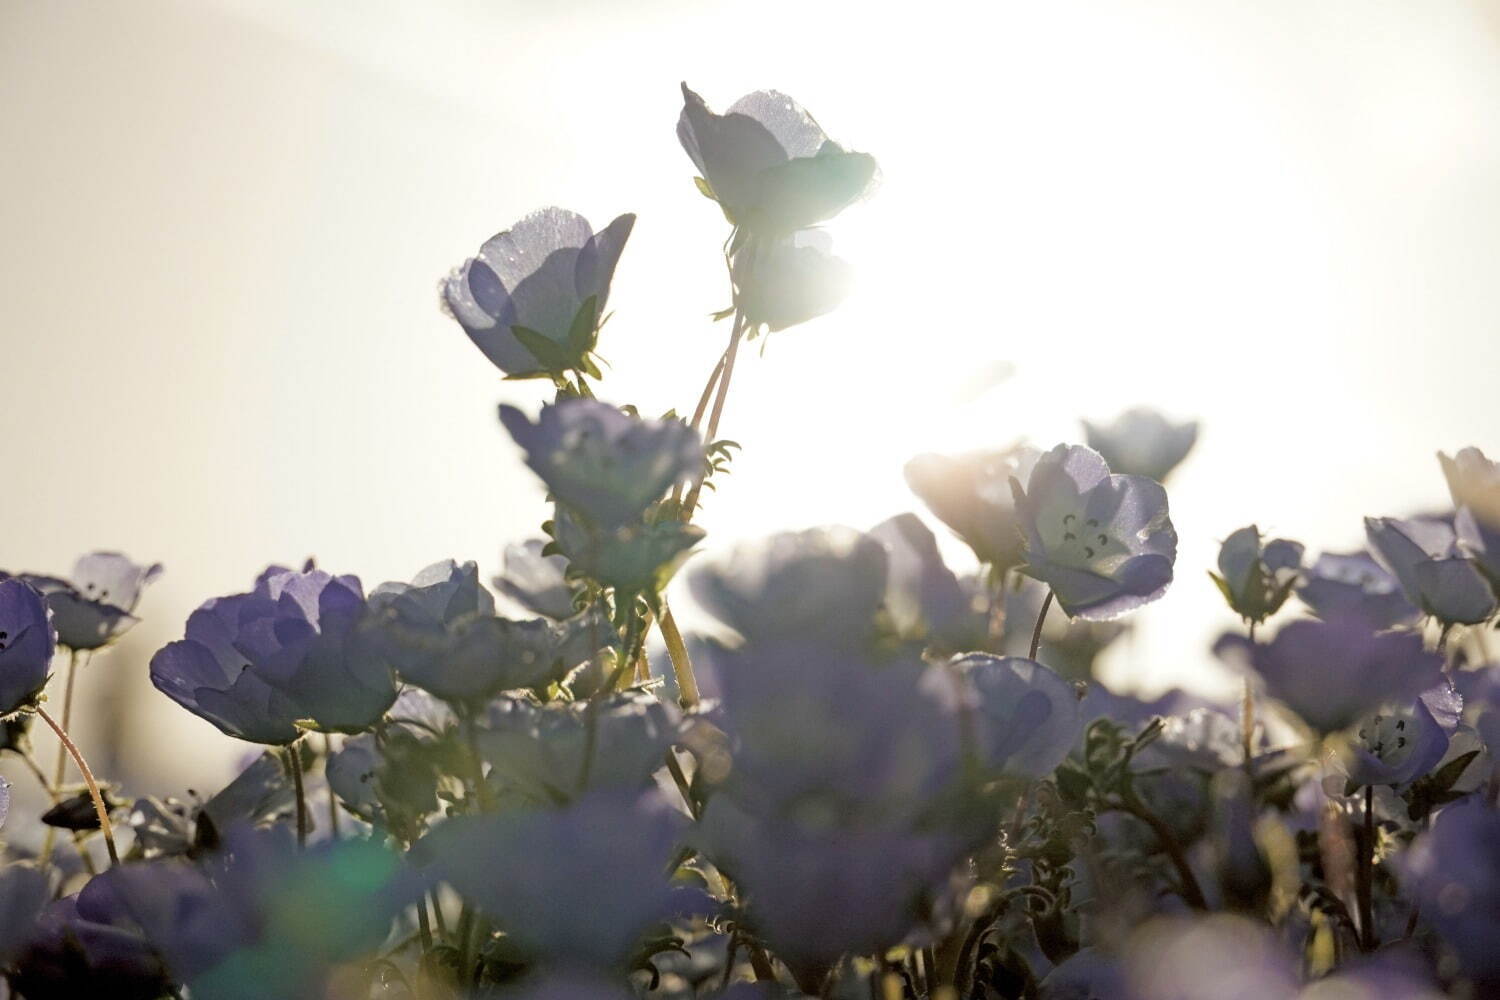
1365;517;1496;625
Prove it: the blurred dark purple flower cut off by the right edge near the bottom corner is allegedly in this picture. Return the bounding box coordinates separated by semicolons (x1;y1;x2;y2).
1398;804;1500;996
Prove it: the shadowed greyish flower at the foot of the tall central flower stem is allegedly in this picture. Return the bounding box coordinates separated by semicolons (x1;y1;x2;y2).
476;694;683;804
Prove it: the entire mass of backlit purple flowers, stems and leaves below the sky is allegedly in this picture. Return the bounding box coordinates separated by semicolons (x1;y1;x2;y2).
0;80;1500;1000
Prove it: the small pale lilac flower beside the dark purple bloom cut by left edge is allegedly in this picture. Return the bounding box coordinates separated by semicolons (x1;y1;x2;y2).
26;552;162;649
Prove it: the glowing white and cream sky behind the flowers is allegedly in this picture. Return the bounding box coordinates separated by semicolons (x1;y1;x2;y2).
0;0;1500;790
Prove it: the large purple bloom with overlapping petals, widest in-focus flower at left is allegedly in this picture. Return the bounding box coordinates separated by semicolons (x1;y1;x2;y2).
152;567;396;744
